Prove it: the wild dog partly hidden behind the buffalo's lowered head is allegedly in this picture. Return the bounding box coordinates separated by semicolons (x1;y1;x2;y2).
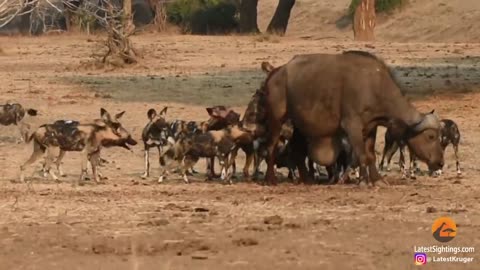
379;119;462;179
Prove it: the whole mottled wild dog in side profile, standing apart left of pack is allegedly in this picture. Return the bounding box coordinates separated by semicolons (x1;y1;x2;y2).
20;108;137;185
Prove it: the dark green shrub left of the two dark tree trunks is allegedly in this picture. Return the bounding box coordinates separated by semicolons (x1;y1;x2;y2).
167;0;238;34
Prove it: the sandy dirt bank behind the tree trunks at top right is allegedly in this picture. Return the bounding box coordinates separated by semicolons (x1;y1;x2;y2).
258;0;480;42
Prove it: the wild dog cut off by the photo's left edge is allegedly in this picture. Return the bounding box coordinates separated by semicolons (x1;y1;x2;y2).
0;102;37;141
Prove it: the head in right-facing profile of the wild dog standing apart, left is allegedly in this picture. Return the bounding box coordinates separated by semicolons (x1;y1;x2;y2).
95;108;137;150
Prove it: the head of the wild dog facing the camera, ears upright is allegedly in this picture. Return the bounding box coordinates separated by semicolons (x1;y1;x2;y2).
142;107;172;146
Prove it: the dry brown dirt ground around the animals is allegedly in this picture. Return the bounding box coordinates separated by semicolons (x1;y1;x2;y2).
0;35;480;270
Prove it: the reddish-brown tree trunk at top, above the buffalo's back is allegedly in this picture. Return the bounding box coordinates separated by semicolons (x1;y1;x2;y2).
353;0;376;41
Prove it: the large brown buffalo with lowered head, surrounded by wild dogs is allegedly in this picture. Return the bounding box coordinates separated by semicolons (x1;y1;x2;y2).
263;51;443;184
